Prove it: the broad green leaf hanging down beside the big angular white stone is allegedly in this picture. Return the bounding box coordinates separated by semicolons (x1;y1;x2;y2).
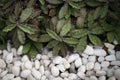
76;37;87;52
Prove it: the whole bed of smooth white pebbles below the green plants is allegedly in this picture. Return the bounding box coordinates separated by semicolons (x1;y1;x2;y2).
0;43;120;80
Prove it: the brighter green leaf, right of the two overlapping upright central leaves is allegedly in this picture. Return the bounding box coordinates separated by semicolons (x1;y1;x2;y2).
60;20;72;36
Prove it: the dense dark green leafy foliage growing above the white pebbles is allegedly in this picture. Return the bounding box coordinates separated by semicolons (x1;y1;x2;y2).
0;0;120;56
